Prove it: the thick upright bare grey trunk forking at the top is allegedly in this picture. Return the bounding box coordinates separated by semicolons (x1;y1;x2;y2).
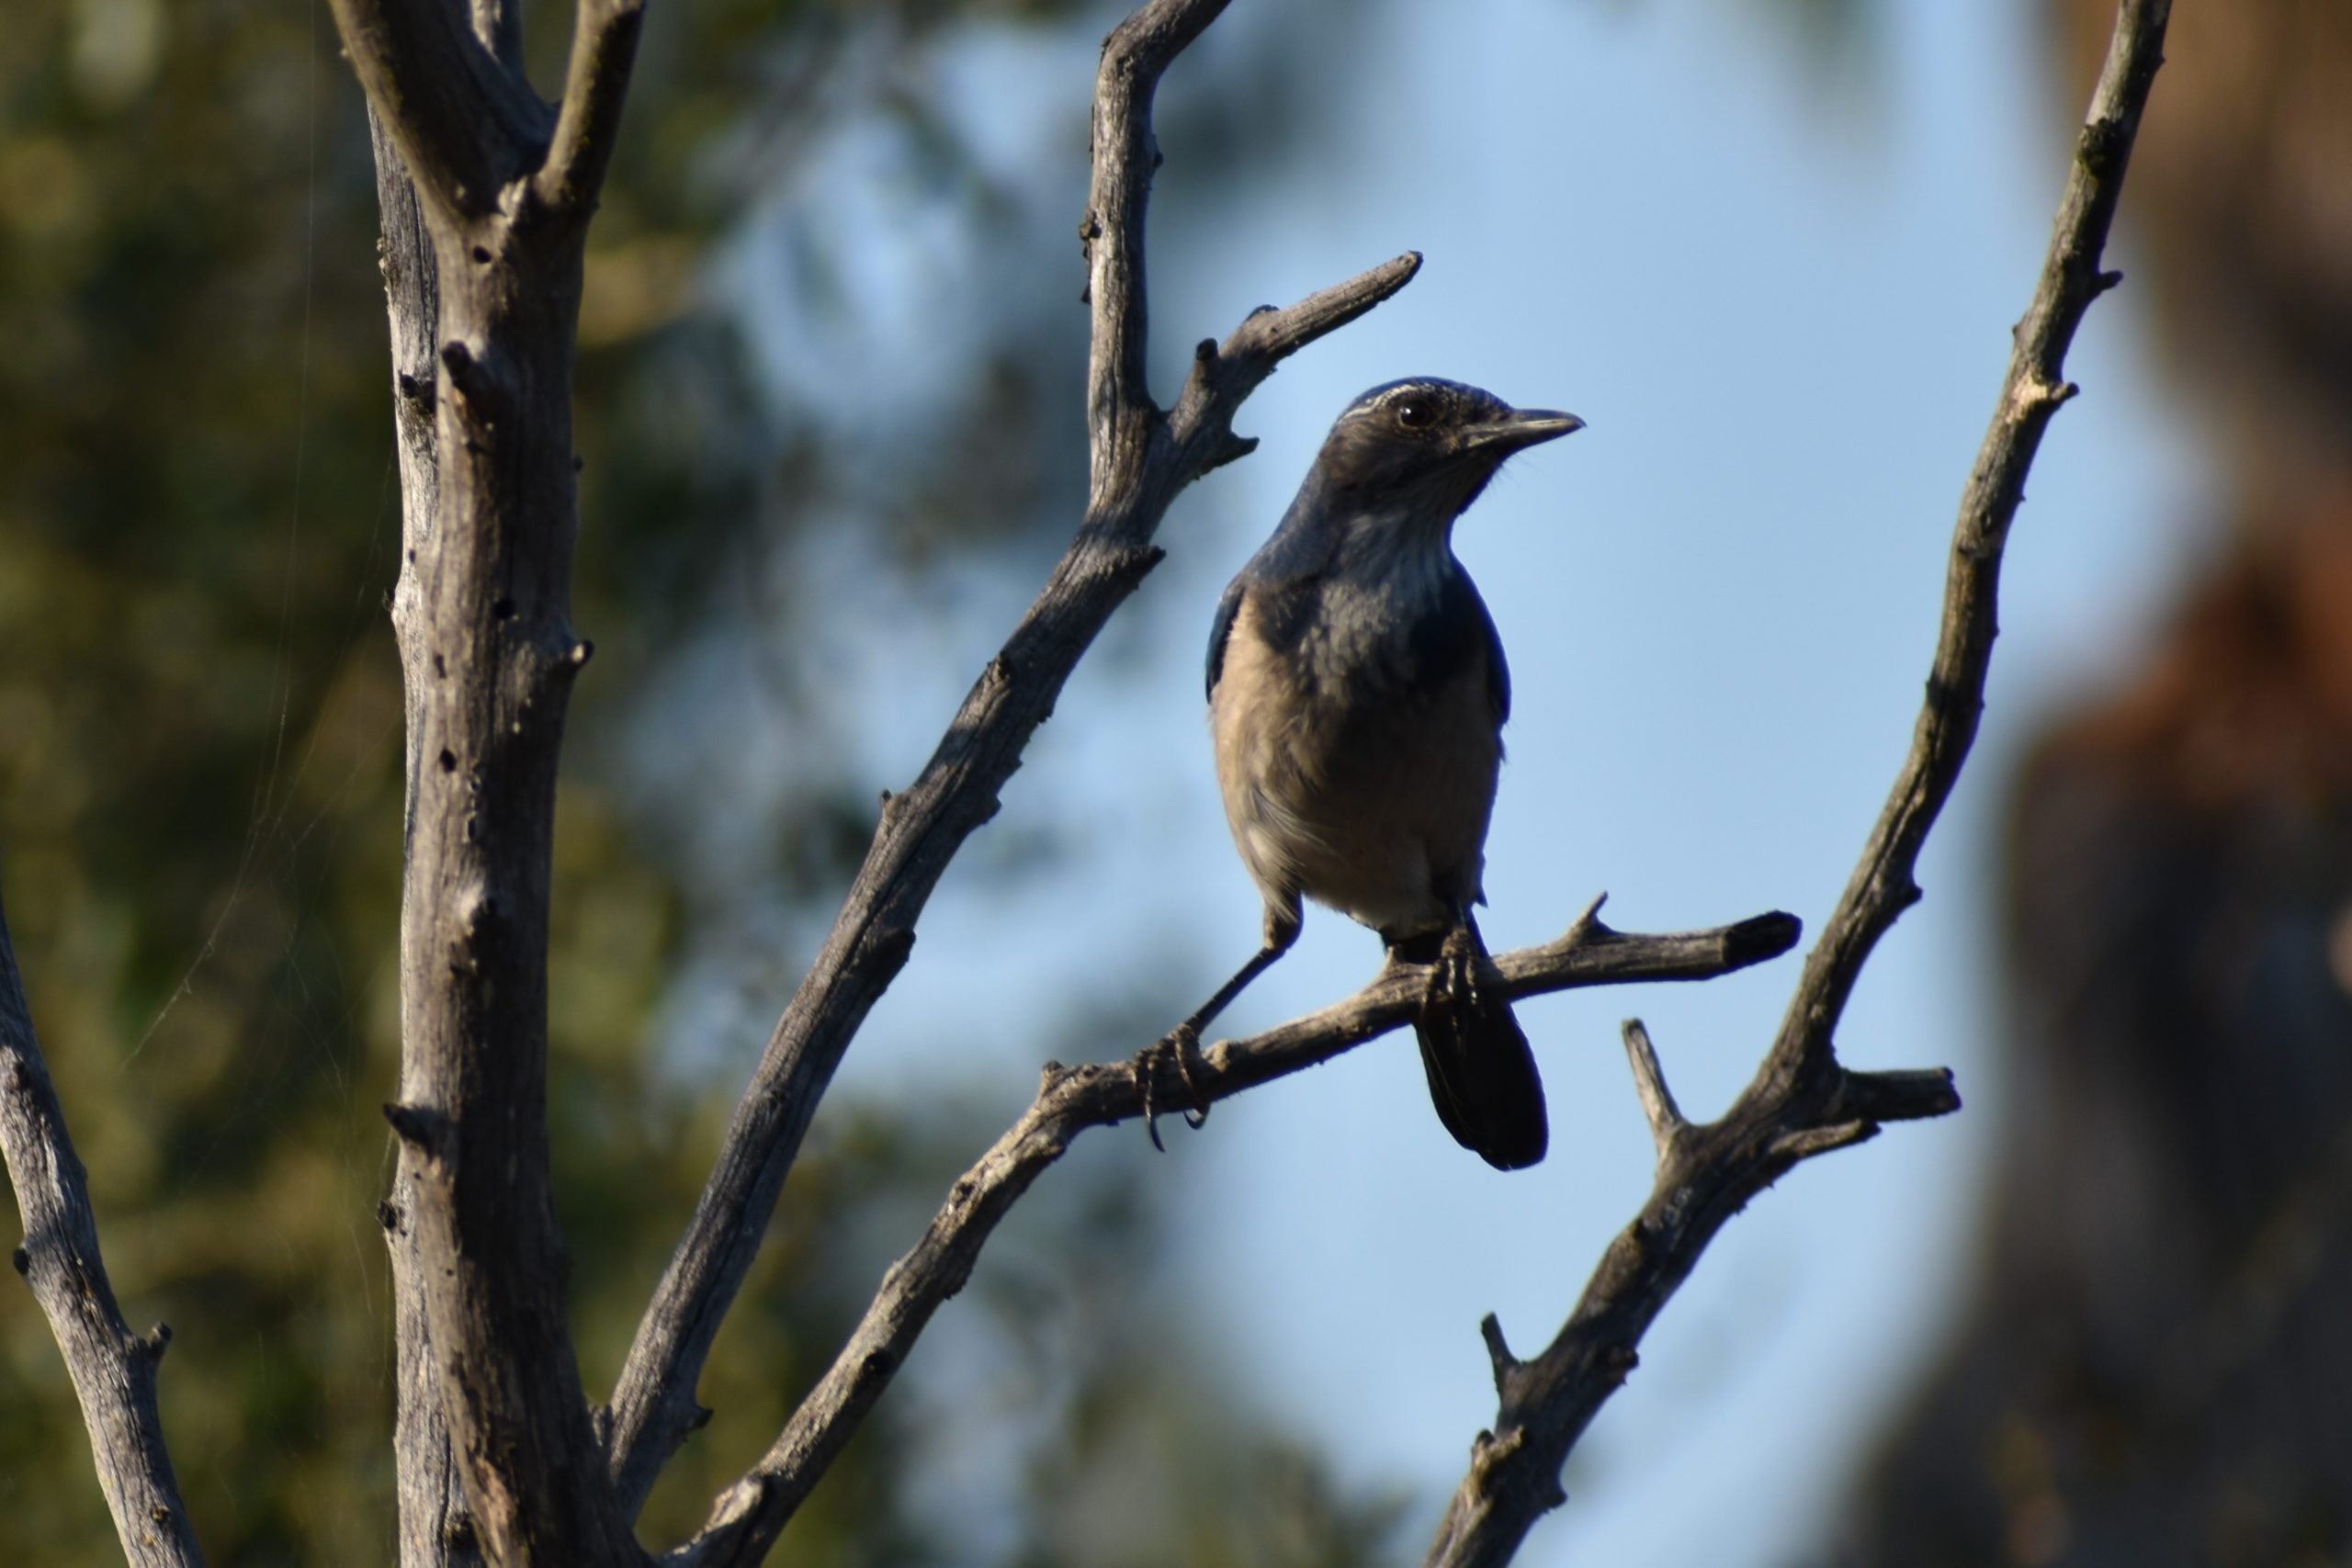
334;0;644;1568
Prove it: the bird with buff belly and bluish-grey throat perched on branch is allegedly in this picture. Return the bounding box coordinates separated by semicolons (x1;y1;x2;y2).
1162;376;1585;1170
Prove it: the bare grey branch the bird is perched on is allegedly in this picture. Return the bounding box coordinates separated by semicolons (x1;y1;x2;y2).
663;909;1797;1568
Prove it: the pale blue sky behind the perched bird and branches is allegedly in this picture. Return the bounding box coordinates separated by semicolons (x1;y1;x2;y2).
706;0;2209;1568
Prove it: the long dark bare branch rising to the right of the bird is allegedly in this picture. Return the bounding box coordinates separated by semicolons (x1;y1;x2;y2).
1425;0;2171;1568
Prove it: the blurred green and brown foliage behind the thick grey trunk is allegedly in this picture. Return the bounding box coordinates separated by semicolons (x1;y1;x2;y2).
0;0;1390;1565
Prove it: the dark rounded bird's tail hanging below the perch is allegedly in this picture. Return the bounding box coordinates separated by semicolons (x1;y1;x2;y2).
1397;917;1550;1170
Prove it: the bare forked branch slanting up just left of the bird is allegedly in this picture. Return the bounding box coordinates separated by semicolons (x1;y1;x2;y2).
605;0;1420;1517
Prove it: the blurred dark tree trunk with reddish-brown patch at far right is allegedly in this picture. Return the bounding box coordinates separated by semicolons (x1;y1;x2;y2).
1837;0;2352;1568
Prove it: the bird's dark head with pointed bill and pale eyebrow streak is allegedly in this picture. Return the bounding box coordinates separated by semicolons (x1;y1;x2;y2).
1310;376;1585;526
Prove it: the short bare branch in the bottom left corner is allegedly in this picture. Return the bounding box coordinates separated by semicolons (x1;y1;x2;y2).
0;888;205;1568
